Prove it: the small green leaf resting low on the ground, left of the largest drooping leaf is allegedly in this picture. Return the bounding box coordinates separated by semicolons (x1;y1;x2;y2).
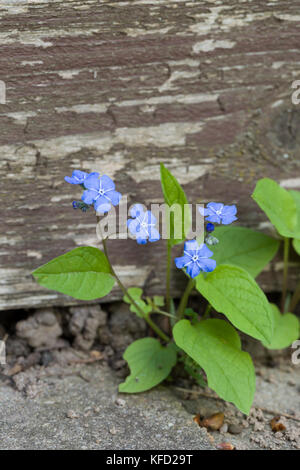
119;338;176;393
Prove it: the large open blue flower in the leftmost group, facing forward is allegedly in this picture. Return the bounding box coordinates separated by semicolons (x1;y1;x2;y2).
81;173;122;213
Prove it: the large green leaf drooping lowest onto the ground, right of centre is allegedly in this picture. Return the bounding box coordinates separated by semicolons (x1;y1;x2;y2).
173;319;255;414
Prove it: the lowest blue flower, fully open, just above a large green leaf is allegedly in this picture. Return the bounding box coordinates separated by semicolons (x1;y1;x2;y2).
175;240;217;279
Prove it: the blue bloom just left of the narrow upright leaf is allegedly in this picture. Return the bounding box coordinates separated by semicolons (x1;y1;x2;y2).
127;204;160;245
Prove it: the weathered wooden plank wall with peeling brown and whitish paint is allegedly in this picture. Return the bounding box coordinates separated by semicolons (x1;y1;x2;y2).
0;0;300;309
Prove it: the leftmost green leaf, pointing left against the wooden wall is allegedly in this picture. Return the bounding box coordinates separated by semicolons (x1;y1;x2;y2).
32;246;115;300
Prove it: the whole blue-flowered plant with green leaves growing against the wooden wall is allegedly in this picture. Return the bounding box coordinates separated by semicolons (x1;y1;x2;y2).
33;164;300;414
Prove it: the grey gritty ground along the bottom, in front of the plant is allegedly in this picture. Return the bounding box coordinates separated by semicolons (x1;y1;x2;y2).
0;348;300;450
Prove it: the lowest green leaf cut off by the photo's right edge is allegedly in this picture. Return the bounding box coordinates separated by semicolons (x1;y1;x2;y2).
263;304;300;349
